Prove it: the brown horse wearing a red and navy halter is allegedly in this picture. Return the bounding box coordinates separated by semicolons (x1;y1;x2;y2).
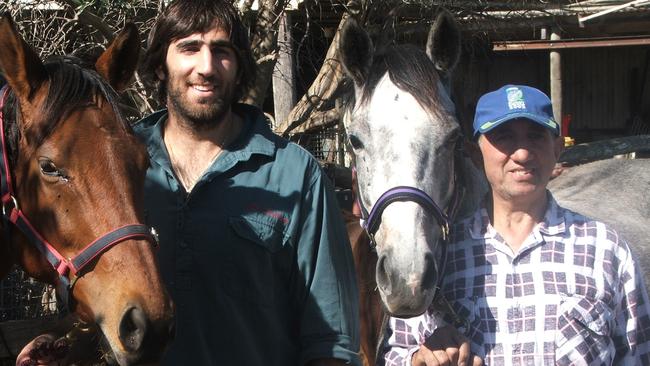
0;17;173;365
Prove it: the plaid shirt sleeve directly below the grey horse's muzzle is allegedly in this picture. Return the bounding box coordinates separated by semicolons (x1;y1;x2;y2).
380;310;446;366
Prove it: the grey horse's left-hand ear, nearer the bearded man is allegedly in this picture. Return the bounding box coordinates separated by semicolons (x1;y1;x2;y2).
339;18;372;86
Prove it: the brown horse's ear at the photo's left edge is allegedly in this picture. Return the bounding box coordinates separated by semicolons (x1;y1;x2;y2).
0;15;47;102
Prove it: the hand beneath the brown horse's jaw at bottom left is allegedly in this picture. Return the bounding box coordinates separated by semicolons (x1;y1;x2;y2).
16;334;68;366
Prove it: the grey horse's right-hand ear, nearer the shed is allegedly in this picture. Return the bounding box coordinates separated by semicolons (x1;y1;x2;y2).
427;10;461;73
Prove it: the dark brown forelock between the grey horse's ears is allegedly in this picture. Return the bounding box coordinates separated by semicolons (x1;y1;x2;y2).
361;44;441;116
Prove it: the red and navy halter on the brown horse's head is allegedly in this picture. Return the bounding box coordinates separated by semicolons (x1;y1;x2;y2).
0;86;158;310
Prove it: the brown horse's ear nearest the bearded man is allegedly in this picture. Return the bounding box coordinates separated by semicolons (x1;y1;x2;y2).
95;23;140;91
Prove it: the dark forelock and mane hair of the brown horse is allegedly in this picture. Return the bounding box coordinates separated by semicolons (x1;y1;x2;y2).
3;56;131;162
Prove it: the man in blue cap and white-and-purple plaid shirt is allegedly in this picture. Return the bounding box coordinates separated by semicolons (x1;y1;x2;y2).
384;85;650;366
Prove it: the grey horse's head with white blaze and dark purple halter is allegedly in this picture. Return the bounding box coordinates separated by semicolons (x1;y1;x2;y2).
341;12;461;316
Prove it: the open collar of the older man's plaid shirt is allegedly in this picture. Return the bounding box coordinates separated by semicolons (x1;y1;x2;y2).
468;191;567;246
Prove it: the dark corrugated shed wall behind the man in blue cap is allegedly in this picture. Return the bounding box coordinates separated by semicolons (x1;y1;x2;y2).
454;42;650;141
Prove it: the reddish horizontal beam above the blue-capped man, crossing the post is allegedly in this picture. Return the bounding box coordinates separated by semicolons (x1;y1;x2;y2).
492;36;650;51
